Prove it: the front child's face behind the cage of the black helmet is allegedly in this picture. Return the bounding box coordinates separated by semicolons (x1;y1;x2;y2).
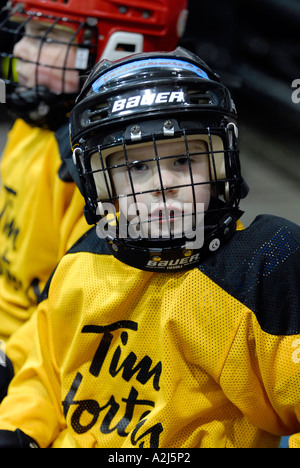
108;139;211;237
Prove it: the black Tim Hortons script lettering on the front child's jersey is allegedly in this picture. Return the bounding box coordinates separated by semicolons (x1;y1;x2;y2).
62;320;163;448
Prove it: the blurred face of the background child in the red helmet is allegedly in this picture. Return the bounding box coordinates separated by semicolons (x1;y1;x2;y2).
14;21;79;94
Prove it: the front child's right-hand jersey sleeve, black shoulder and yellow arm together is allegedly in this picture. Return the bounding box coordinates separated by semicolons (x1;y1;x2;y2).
213;216;300;439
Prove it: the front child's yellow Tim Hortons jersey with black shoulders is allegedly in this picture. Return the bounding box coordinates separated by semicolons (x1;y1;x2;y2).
0;216;300;448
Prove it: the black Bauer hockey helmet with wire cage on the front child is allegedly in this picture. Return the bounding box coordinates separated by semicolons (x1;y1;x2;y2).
70;48;247;272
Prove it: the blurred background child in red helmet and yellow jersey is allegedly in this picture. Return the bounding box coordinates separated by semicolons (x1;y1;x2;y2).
0;0;186;394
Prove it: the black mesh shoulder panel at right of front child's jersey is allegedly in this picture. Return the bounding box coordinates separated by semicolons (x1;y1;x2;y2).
199;215;300;335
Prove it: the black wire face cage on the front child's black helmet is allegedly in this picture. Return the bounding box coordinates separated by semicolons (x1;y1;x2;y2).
74;119;243;270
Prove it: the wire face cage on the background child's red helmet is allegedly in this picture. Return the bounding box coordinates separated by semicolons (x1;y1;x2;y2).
0;4;97;88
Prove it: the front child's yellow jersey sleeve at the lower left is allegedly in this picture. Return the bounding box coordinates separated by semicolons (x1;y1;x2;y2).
0;301;65;448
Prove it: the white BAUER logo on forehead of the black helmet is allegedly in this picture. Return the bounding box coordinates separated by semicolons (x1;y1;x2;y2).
112;90;186;113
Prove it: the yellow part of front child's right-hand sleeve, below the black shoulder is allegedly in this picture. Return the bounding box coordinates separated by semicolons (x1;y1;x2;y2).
220;314;300;436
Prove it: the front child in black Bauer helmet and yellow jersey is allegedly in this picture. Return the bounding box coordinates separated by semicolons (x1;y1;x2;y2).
0;49;300;449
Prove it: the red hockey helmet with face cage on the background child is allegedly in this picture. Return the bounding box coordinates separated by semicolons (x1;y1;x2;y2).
0;0;187;128
